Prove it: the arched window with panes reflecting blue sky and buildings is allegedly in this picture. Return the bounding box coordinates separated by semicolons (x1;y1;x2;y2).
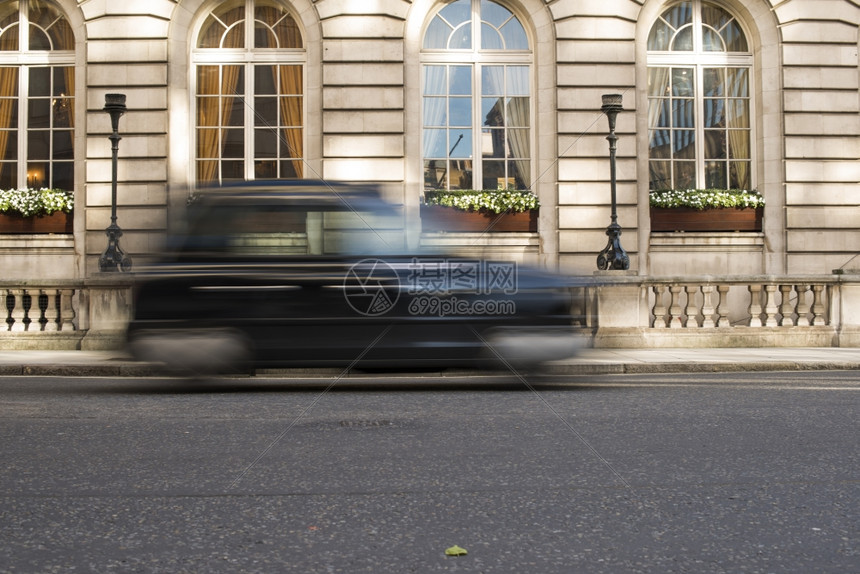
421;0;533;194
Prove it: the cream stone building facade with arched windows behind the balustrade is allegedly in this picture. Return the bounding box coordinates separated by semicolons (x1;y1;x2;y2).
0;0;860;279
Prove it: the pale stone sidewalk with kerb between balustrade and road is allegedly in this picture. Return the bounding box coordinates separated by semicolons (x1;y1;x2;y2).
0;347;860;378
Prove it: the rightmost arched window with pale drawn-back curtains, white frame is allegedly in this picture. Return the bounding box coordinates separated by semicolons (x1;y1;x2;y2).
648;0;754;189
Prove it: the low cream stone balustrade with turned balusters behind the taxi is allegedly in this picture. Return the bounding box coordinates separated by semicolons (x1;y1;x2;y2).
0;271;860;349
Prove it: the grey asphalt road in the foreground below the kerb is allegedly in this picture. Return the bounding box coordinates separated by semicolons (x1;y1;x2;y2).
0;371;860;574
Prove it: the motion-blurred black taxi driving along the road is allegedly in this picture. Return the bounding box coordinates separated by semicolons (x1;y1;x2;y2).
128;181;576;373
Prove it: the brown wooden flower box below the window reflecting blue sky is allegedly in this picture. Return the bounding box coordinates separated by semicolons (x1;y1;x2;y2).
421;205;538;233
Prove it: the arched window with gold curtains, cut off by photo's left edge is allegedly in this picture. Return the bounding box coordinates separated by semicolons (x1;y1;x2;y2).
0;0;75;190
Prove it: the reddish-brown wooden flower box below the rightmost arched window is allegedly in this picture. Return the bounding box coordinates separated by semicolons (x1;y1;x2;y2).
651;207;764;232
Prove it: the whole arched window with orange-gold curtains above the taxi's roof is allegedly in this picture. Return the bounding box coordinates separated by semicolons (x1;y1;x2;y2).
192;0;305;185
